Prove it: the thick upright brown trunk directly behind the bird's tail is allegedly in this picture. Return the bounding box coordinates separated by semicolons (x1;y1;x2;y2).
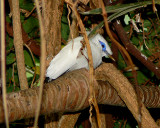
43;0;64;59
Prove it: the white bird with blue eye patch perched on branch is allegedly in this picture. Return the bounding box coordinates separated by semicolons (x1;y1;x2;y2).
46;34;112;81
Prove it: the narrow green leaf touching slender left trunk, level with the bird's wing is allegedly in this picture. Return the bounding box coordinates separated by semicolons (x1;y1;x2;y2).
24;50;34;67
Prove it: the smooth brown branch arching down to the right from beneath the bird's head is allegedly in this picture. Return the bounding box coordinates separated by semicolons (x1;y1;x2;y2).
95;65;158;128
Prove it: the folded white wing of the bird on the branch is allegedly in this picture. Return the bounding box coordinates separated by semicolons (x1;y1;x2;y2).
46;38;82;79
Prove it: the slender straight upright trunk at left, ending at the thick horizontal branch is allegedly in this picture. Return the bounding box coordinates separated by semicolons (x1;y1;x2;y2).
12;0;28;90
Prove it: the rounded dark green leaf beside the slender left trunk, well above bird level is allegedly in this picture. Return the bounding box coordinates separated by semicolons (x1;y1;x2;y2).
23;17;39;33
